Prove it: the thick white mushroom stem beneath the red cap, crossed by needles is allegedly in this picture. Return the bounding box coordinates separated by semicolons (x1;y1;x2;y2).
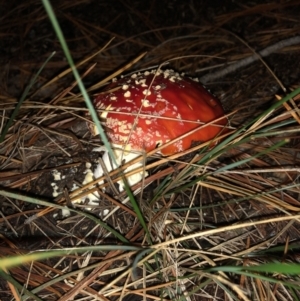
94;144;148;192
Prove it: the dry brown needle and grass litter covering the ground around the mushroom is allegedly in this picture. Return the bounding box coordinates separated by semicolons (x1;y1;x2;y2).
0;0;300;301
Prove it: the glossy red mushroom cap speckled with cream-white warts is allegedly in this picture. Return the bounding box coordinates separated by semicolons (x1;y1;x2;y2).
94;70;228;155
